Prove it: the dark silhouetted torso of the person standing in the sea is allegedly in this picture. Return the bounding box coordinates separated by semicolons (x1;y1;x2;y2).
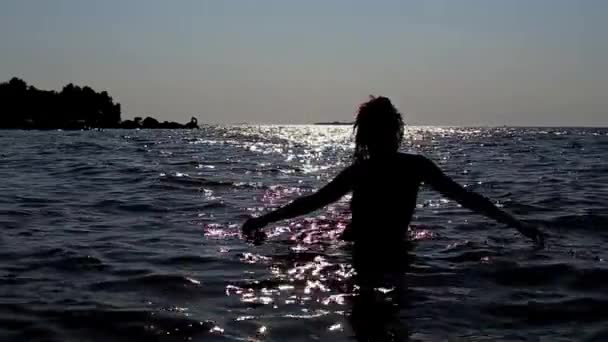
347;153;421;273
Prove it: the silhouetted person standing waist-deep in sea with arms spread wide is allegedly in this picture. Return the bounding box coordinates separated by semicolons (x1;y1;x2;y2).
242;97;543;272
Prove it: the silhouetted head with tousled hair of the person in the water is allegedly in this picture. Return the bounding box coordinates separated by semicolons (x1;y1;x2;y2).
353;96;403;163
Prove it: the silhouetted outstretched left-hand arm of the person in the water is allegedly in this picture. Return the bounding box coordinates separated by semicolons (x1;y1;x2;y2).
242;166;353;235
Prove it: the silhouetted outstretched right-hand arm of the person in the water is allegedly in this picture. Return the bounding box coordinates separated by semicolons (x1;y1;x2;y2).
421;157;543;244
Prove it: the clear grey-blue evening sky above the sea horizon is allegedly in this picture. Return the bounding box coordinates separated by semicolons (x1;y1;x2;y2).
0;0;608;126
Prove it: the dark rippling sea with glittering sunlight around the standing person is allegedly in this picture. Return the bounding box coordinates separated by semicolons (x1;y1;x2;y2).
0;126;608;341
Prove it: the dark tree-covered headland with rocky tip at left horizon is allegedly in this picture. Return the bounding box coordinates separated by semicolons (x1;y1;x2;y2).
0;77;199;129
